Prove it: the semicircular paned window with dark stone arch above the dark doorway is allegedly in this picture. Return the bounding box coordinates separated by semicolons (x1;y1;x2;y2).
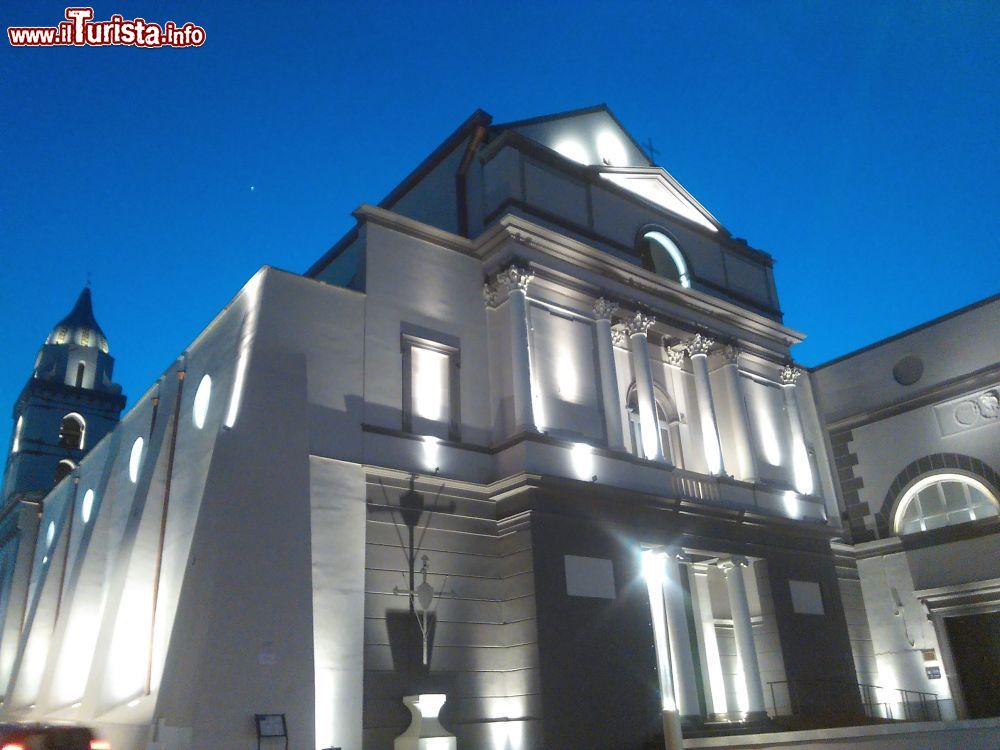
893;474;1000;534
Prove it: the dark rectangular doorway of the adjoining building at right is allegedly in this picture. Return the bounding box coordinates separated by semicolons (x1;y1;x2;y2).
945;612;1000;719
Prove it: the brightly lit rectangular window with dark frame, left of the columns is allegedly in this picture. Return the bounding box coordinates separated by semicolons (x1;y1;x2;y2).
402;334;461;440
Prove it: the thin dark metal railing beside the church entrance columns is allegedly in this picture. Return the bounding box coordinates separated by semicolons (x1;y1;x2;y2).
767;680;942;721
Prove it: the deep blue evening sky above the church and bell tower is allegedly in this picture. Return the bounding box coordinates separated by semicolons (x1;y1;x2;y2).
0;0;1000;452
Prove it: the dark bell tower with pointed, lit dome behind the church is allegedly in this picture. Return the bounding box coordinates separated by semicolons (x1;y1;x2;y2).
3;286;125;507
